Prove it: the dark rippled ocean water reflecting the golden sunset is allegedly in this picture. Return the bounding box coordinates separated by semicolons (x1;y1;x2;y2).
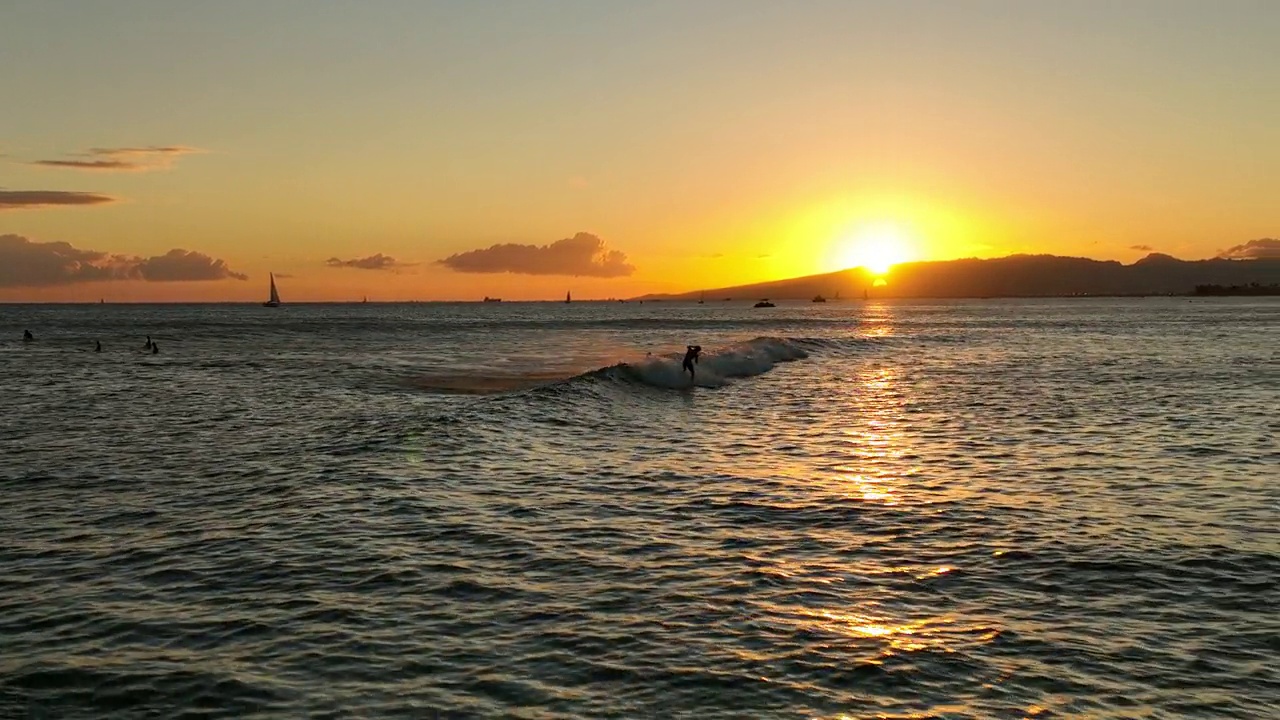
0;299;1280;720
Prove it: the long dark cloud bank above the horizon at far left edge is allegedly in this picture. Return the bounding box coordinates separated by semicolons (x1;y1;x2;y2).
0;234;248;287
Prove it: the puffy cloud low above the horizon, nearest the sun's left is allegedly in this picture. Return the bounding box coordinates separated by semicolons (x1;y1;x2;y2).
438;232;636;278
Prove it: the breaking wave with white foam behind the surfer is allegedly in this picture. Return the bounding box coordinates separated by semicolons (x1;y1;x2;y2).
407;337;814;395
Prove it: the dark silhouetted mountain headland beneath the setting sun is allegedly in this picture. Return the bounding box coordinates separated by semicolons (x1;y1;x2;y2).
636;254;1280;300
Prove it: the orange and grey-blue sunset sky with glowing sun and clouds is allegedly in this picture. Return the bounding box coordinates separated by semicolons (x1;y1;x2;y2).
0;0;1280;302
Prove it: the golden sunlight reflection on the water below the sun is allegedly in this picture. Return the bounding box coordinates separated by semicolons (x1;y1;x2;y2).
747;304;1044;719
